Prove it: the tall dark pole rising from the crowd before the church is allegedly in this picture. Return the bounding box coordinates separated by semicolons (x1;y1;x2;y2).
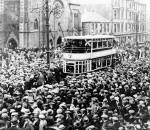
45;0;50;68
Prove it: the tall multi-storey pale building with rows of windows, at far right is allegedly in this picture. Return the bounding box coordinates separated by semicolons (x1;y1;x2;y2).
111;0;147;43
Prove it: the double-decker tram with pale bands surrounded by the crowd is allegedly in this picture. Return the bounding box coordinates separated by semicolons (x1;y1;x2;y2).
63;35;117;74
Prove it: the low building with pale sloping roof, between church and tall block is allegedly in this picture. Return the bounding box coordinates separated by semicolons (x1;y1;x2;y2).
81;11;111;35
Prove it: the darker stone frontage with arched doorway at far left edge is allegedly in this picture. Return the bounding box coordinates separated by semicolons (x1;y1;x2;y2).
0;0;20;48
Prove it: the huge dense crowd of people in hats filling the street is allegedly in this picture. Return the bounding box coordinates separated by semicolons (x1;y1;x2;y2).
0;49;150;130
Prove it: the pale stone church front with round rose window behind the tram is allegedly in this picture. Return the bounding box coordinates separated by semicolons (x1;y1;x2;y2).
19;0;81;48
